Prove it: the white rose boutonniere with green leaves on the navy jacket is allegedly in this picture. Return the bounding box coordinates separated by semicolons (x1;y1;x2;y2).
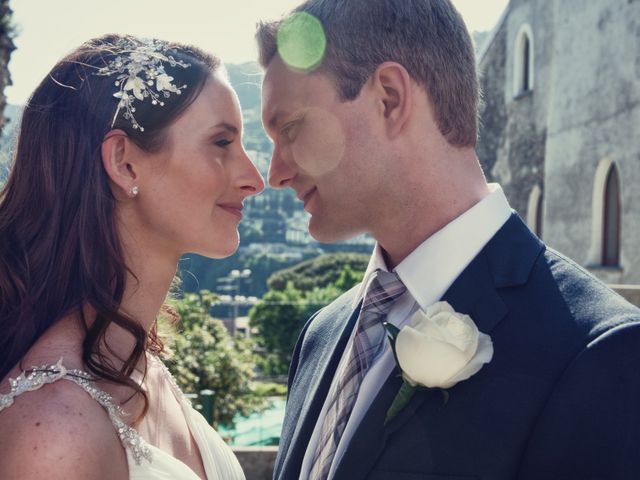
384;302;493;424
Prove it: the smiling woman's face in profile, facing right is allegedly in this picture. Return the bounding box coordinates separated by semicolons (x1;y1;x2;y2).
133;74;264;258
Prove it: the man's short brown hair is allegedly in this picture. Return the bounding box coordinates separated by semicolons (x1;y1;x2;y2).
256;0;479;147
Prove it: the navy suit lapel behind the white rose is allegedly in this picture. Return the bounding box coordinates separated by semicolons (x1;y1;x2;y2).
334;214;543;480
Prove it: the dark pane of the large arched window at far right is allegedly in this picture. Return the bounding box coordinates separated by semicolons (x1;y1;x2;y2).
602;164;620;267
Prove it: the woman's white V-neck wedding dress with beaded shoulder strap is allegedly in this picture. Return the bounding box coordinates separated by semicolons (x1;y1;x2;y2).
0;359;245;480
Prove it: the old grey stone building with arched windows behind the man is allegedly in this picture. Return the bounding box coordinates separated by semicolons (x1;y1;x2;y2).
478;0;640;284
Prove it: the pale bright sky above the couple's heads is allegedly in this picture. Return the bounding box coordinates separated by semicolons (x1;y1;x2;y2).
5;0;508;105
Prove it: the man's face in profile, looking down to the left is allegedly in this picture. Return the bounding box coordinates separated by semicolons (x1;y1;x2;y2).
262;56;384;242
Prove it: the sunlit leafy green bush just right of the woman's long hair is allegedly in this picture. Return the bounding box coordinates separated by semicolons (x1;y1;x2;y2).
166;290;264;427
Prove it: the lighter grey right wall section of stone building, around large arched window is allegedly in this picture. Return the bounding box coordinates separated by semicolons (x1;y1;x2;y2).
544;0;640;283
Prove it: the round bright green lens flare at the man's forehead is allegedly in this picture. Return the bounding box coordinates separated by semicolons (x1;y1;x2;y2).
278;12;327;73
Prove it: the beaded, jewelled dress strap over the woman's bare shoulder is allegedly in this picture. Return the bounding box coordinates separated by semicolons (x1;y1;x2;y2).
0;358;151;465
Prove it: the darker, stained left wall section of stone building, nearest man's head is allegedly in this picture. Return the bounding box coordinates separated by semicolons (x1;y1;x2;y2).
477;0;546;223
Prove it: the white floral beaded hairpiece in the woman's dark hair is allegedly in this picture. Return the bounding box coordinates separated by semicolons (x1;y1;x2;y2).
96;38;191;132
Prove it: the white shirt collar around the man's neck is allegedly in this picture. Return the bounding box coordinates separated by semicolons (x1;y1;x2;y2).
354;183;512;310
